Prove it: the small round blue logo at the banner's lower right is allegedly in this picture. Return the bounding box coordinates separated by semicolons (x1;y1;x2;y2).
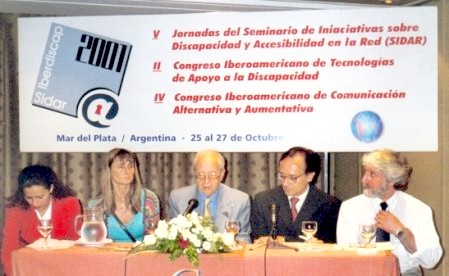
351;111;383;143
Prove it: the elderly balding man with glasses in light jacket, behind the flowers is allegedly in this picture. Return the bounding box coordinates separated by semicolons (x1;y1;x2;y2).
168;150;251;243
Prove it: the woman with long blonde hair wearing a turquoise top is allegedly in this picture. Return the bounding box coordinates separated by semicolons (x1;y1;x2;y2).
88;148;160;242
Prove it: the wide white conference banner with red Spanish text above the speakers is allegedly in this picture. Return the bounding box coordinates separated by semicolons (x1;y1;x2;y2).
18;7;438;152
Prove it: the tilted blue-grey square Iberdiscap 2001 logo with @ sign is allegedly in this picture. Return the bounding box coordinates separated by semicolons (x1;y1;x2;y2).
32;23;132;128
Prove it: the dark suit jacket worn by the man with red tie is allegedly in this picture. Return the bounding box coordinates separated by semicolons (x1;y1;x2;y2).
251;185;341;243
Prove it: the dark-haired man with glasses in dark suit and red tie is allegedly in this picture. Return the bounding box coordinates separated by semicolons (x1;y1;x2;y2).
251;147;341;243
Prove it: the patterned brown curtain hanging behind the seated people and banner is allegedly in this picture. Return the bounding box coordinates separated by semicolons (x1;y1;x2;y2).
0;14;304;234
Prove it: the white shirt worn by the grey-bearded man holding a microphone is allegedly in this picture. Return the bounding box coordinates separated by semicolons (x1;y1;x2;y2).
337;191;443;272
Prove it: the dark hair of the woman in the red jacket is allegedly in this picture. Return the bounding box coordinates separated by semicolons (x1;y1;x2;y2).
6;165;75;209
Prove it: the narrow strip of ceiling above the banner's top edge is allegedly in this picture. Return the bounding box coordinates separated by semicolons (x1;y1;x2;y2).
0;0;436;16
